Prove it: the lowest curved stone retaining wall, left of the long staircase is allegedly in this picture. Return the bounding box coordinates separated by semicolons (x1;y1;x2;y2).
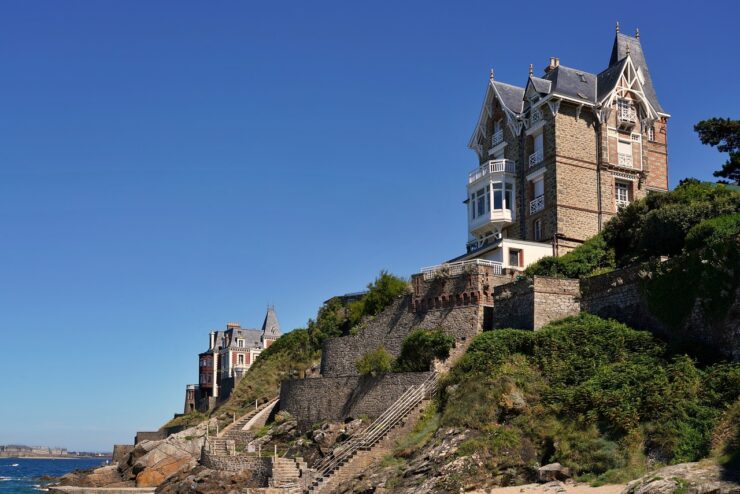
280;372;429;429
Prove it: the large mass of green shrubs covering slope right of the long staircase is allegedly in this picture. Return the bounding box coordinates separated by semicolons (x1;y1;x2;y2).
384;314;740;485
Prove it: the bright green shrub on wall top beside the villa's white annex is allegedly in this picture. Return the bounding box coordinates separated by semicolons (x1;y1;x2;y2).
524;235;615;278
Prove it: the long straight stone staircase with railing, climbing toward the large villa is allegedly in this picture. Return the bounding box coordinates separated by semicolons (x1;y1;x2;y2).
303;372;438;494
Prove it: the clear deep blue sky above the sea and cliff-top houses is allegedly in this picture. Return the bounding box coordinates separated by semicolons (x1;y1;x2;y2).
0;0;740;450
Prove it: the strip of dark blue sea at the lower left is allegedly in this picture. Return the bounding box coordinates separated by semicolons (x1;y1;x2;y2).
0;458;105;494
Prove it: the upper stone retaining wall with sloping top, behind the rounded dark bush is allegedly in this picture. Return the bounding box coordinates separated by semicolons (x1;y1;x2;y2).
321;295;484;377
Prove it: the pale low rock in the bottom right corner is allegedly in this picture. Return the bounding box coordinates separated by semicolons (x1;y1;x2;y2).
622;461;740;494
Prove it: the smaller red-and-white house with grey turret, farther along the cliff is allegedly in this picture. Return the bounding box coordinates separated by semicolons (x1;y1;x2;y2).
185;306;281;413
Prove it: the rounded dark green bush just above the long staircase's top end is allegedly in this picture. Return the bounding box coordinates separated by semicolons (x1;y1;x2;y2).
393;328;455;372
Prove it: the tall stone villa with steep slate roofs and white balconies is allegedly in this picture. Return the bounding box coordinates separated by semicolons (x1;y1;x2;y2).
426;24;670;282
